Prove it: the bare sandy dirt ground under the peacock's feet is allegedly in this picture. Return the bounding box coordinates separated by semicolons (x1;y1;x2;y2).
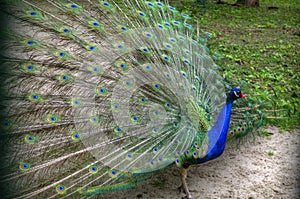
110;127;300;199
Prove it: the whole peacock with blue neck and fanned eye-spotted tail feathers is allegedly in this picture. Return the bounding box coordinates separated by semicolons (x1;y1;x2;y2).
0;0;264;199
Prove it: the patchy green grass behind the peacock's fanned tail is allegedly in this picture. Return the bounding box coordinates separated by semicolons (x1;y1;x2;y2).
171;0;300;129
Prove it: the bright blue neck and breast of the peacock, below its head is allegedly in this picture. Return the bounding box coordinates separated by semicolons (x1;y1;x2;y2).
187;99;232;166
